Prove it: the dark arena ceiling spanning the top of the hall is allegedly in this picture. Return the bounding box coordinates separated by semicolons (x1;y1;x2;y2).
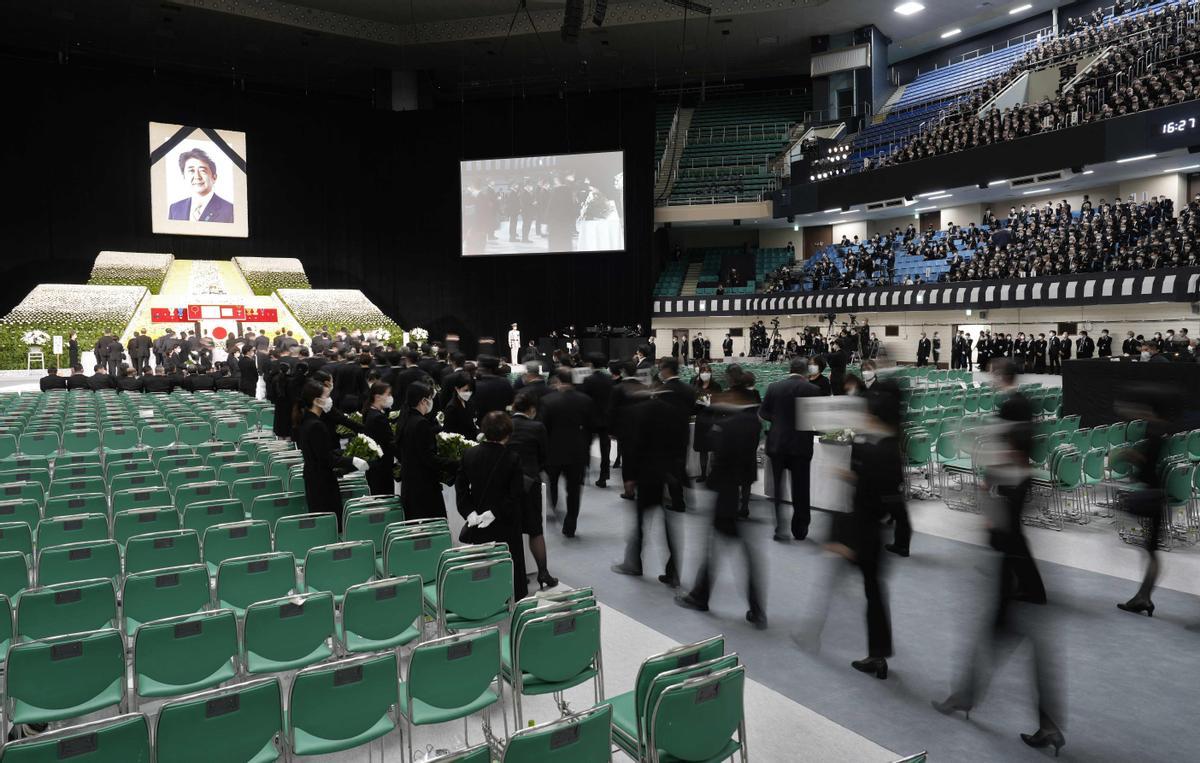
0;0;1052;94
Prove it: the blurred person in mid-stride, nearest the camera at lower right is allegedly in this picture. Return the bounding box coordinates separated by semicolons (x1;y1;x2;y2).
932;359;1067;756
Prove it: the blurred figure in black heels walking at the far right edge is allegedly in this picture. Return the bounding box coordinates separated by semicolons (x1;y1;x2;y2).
1112;385;1178;617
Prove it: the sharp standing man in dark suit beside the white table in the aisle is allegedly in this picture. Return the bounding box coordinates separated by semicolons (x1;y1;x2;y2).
758;358;821;541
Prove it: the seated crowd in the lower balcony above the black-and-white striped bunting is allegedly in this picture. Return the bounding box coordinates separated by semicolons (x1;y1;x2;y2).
796;194;1200;290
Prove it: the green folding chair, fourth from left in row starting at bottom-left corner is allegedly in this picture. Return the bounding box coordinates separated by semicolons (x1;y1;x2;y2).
400;627;508;761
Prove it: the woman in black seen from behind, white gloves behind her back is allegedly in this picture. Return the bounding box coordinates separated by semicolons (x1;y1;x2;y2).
451;410;529;599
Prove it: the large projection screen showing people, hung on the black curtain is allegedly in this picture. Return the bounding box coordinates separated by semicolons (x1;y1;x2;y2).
460;151;625;256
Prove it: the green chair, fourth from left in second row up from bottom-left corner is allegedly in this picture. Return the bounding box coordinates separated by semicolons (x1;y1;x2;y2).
342;575;424;653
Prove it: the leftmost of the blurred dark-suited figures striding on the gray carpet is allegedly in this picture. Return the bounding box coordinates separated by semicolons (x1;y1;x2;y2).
612;382;688;588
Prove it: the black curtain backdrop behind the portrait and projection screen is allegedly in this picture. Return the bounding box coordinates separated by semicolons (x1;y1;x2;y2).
0;61;654;352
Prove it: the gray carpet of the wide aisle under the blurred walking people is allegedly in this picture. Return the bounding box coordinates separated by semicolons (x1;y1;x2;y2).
547;483;1200;761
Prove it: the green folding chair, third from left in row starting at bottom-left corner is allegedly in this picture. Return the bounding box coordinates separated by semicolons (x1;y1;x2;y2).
287;651;397;758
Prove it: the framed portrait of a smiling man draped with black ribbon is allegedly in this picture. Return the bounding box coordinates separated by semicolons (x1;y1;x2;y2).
150;122;250;239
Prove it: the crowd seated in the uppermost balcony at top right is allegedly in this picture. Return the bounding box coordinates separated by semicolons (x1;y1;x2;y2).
864;0;1200;169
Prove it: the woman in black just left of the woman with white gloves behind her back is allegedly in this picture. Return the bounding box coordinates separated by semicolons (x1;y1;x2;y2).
395;382;450;519
